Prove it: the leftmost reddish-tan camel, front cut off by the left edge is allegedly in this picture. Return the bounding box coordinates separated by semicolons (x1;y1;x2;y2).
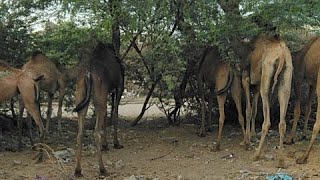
0;62;44;157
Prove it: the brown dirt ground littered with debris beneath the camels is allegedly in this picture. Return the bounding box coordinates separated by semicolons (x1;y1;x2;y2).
0;100;320;180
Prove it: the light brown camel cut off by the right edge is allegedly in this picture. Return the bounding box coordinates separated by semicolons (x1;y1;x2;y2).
296;37;320;164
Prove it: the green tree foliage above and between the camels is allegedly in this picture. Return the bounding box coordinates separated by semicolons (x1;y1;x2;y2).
0;0;320;121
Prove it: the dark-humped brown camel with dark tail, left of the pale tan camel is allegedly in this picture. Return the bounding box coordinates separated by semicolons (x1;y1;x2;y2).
198;47;250;150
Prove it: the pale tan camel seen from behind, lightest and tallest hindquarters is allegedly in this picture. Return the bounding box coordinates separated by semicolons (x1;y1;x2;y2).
243;35;293;167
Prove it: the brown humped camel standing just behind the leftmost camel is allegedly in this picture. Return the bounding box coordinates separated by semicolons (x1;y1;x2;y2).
19;51;67;135
